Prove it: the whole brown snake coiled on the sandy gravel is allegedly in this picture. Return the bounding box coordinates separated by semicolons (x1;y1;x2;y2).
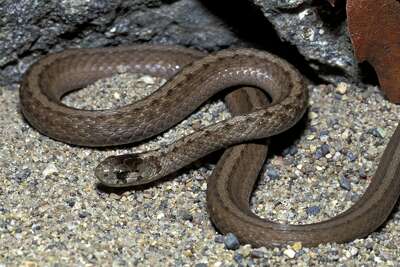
20;45;400;246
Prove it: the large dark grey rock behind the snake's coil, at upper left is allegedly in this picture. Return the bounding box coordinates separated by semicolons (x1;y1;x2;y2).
0;0;239;85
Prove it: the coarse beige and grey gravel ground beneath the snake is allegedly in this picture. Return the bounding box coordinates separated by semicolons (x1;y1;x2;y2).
0;74;400;267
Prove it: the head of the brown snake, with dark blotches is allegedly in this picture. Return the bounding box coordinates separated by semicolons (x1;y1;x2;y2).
95;154;160;187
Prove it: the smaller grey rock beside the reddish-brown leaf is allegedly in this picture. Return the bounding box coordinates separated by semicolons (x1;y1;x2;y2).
252;0;360;81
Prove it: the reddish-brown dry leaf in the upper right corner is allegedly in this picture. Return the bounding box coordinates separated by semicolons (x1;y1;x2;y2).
347;0;400;103
